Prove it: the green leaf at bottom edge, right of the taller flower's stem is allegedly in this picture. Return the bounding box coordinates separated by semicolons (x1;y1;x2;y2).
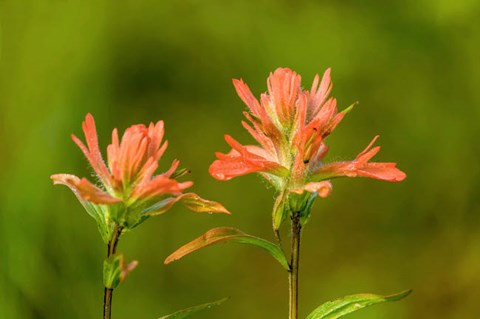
306;290;412;319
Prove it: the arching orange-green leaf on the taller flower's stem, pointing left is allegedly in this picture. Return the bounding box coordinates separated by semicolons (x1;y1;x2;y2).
165;227;290;270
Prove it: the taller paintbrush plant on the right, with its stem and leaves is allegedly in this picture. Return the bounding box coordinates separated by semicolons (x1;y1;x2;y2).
165;68;410;319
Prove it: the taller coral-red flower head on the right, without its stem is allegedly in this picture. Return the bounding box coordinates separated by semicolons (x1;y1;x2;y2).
209;68;406;228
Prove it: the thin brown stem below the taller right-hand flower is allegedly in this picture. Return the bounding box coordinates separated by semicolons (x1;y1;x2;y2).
288;212;302;319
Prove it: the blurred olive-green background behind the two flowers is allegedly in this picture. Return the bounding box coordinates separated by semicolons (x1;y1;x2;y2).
0;0;480;319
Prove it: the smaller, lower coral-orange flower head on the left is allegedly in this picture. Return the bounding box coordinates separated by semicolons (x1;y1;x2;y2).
51;114;228;239
